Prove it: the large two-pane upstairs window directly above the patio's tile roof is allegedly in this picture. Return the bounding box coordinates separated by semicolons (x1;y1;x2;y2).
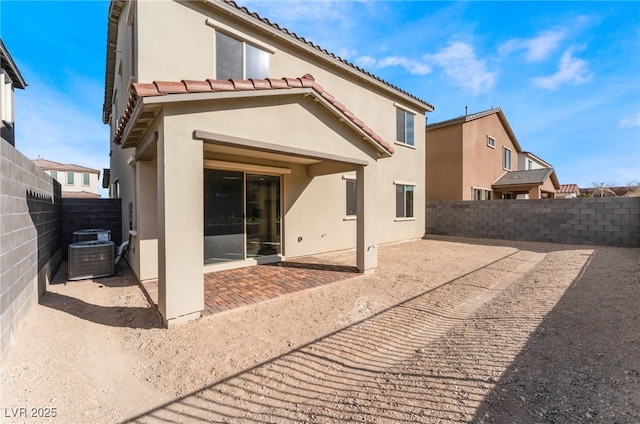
216;31;269;80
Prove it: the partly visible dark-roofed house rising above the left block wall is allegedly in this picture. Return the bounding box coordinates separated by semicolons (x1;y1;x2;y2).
0;39;27;146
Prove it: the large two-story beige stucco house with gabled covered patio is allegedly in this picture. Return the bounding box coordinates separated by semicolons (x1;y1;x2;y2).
103;1;433;325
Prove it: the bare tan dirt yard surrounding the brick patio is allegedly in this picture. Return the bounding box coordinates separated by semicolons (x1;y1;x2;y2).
0;239;640;424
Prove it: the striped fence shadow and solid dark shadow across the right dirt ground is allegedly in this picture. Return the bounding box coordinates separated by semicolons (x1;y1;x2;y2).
117;242;640;423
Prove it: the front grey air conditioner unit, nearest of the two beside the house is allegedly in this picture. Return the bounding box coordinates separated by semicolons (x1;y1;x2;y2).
69;241;115;280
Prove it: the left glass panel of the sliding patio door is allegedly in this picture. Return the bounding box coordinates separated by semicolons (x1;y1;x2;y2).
204;169;244;264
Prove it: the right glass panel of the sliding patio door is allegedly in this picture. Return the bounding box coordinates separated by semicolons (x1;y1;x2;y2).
246;174;281;258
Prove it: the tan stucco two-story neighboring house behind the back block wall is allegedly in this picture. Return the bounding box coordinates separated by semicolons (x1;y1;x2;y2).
426;108;560;200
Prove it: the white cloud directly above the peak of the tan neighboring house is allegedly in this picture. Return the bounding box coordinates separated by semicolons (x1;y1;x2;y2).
425;42;496;95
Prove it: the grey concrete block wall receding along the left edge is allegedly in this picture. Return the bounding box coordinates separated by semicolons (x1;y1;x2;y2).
0;140;62;356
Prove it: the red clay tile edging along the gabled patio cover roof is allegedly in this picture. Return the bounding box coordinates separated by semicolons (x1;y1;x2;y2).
114;74;394;154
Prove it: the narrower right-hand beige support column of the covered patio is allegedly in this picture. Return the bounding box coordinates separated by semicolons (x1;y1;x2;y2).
356;166;378;273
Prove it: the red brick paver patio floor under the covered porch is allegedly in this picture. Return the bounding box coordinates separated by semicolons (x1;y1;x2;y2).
143;261;358;316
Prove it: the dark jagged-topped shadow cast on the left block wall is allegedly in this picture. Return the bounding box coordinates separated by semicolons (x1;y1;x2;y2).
25;186;62;297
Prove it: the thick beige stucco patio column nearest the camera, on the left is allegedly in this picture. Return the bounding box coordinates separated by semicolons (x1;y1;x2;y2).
157;126;204;326
